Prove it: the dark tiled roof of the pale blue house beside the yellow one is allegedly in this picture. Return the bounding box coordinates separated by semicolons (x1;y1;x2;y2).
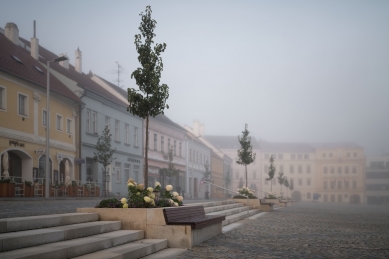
20;38;128;107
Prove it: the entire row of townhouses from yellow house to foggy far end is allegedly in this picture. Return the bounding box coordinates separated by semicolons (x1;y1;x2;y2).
0;23;376;203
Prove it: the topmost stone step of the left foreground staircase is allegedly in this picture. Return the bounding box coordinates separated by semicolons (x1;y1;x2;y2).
0;213;99;233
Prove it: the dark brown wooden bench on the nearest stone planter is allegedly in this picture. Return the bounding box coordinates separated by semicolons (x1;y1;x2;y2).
163;206;226;229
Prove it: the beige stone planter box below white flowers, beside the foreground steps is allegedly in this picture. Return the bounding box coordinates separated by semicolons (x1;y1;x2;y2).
77;208;222;249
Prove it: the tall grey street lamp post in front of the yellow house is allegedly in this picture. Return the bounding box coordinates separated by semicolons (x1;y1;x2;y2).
45;56;68;198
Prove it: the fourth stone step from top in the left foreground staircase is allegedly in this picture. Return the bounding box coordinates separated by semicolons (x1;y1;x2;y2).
75;239;167;259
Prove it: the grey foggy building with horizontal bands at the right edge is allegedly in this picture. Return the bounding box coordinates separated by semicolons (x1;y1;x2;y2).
365;154;389;204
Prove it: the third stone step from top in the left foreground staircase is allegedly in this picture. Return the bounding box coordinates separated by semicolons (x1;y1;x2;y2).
0;230;144;259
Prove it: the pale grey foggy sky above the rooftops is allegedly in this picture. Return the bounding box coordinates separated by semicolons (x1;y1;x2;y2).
0;0;389;155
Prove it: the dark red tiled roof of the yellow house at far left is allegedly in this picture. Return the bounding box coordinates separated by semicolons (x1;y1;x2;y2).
0;33;82;103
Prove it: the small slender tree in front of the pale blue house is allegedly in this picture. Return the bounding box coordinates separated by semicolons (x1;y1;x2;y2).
93;126;116;197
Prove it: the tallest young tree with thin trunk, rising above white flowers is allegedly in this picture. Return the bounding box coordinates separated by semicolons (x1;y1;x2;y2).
127;6;169;189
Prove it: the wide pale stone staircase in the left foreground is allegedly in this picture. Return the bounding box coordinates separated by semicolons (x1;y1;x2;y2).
0;213;181;259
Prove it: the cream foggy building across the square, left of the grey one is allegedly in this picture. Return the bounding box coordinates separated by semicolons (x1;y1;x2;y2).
311;143;366;203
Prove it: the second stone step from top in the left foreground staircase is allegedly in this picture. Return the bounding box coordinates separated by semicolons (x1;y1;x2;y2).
0;221;121;252
